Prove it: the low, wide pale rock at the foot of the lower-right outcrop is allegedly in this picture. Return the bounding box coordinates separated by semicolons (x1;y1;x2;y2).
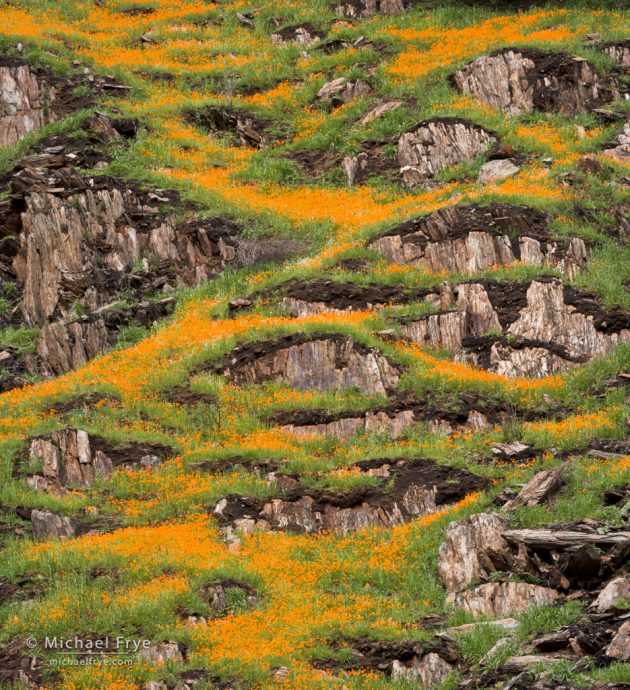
446;582;559;617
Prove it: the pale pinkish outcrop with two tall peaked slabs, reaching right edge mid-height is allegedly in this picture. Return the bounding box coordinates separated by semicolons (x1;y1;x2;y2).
401;278;630;378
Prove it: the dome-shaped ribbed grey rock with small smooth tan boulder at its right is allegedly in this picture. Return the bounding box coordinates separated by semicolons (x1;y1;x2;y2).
397;117;498;187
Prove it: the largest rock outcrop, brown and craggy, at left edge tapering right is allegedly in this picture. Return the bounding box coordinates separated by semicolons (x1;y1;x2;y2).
0;164;296;374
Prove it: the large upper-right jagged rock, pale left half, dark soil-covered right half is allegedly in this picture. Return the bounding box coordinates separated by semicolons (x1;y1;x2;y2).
452;48;617;115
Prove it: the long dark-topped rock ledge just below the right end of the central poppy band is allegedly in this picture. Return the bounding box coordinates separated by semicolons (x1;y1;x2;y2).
369;203;588;278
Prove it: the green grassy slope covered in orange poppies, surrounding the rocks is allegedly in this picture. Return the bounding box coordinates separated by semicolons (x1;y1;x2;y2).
0;0;630;689
